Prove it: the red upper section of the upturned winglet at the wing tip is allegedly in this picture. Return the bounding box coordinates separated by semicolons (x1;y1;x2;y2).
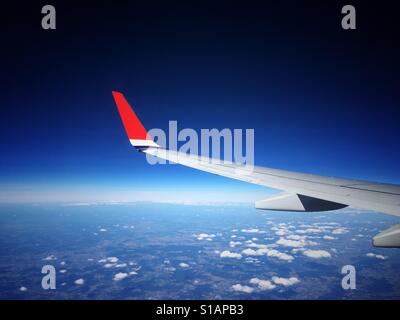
112;91;148;140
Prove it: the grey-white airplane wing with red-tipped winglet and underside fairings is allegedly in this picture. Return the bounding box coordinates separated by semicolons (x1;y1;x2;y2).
113;91;400;247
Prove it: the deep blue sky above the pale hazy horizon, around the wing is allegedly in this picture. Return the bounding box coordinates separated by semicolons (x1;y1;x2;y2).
0;1;400;200
